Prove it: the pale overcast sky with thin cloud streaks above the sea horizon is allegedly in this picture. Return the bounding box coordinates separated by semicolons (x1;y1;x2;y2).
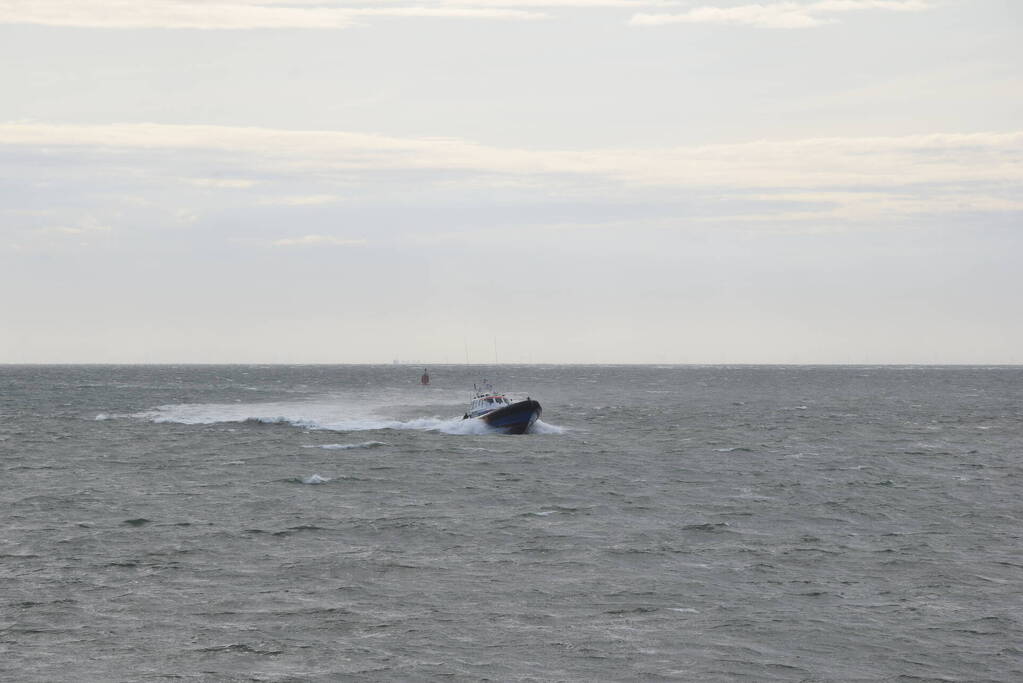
0;0;1023;364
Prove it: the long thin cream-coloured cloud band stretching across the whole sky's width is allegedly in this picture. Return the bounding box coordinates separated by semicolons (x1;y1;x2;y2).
0;123;1023;192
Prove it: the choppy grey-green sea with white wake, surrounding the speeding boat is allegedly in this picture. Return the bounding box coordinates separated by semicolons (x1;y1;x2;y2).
0;365;1023;683
